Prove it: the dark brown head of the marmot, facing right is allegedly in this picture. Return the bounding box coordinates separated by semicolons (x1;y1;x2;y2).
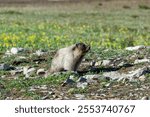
74;43;90;55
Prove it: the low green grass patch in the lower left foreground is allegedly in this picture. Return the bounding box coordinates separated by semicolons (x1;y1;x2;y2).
0;74;69;99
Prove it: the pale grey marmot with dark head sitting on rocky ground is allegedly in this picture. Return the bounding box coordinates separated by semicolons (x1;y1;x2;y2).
47;43;90;75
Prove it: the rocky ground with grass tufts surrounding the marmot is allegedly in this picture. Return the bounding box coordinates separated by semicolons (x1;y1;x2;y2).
0;46;150;100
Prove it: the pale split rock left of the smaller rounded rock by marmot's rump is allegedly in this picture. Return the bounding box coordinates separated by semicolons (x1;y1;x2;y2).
23;66;36;78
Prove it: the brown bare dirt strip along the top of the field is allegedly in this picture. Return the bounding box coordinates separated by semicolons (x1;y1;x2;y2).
0;0;150;9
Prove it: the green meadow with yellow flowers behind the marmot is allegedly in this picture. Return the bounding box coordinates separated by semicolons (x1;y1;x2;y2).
0;4;150;51
